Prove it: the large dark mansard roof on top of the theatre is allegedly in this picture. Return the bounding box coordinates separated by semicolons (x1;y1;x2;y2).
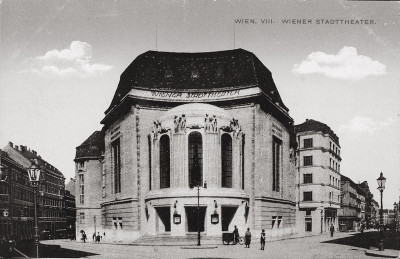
106;49;288;113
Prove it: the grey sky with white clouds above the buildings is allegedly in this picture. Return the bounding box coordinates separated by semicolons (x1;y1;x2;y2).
0;0;400;208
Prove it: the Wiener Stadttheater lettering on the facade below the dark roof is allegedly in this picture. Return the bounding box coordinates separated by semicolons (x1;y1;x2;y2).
151;90;240;99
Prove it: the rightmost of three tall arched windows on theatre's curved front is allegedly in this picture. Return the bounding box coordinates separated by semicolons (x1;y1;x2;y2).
221;134;232;188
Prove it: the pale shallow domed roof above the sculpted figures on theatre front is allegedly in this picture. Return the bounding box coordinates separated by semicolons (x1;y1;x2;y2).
161;103;231;120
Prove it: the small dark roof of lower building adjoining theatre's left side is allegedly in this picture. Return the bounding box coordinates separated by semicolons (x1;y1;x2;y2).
75;131;104;160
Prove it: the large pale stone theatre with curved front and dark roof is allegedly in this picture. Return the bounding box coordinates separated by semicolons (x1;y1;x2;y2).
101;49;296;240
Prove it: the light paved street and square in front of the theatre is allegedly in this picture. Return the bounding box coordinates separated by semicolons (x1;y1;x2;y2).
41;232;399;259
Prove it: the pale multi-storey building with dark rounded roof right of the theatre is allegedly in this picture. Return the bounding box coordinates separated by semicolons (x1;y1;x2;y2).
295;119;341;234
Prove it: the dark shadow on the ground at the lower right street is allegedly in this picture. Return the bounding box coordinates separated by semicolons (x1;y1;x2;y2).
322;231;400;250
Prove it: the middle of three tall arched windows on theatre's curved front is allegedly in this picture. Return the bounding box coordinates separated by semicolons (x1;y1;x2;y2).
189;131;203;187
